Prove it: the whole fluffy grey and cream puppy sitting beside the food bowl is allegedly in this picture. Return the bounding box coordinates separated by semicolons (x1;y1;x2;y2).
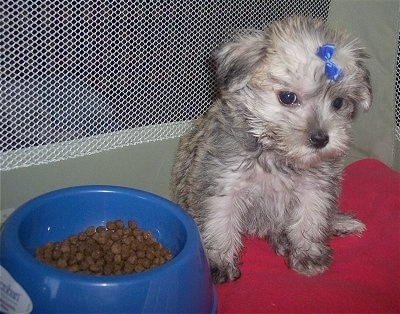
171;17;372;283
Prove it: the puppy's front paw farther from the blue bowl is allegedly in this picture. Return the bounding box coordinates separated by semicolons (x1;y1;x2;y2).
288;246;332;276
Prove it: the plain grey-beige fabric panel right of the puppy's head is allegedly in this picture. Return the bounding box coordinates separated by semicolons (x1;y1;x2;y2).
329;0;400;170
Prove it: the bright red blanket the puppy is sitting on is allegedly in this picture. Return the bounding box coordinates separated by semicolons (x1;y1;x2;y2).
217;159;400;313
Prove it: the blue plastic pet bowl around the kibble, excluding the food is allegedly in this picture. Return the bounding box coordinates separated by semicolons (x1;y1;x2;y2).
0;186;216;313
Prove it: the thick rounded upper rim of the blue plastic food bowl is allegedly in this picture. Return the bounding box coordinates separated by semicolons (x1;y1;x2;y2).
1;185;202;285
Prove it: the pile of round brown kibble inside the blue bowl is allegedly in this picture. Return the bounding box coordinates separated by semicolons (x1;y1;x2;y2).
36;220;172;275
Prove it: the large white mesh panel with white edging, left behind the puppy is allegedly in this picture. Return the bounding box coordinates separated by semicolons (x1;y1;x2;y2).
0;0;330;170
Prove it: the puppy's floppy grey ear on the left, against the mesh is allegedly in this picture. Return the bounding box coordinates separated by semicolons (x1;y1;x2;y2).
213;32;267;92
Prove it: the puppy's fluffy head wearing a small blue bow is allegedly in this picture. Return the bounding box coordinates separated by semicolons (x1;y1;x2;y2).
215;17;372;168
